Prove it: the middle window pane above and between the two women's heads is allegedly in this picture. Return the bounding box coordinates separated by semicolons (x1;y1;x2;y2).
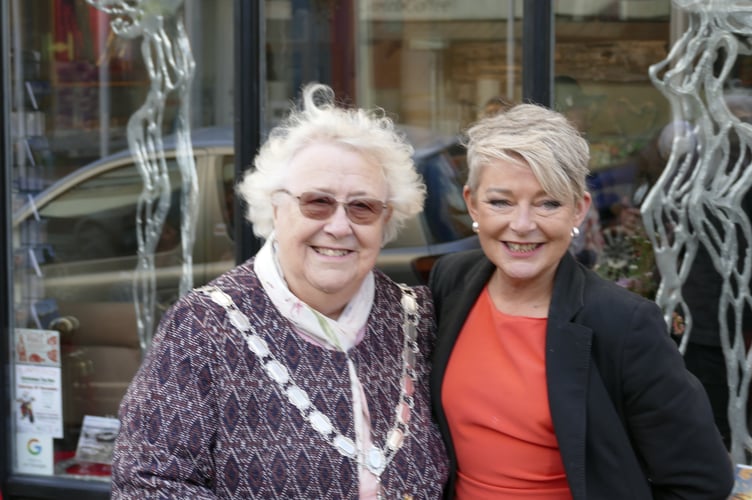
266;0;522;135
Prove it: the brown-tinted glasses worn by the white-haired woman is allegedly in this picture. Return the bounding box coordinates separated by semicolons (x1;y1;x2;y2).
276;189;388;225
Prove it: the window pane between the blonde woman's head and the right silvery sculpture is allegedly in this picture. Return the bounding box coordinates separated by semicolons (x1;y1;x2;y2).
552;0;672;286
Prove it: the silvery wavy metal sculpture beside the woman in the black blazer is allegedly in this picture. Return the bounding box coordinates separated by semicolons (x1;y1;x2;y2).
641;0;752;463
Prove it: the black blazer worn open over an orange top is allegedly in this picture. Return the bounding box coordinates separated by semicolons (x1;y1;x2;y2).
429;250;734;500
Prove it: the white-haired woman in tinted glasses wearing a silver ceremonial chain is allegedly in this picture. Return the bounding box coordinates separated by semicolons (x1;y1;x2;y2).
112;84;448;499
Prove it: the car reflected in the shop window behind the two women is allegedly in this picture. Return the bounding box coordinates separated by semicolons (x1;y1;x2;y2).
13;128;478;426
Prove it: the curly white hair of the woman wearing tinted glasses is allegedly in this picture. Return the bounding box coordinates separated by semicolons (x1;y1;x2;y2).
237;83;426;243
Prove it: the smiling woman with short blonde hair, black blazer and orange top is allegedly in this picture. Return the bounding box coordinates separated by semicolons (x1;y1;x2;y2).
429;104;733;500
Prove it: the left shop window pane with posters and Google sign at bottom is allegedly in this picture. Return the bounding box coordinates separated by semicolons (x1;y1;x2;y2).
4;0;235;481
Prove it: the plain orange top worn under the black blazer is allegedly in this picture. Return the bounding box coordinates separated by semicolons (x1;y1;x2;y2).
442;287;572;500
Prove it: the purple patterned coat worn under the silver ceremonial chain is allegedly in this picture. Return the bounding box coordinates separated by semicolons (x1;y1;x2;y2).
112;260;447;499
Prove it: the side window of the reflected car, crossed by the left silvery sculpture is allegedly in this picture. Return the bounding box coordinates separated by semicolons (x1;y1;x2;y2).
37;159;181;263
